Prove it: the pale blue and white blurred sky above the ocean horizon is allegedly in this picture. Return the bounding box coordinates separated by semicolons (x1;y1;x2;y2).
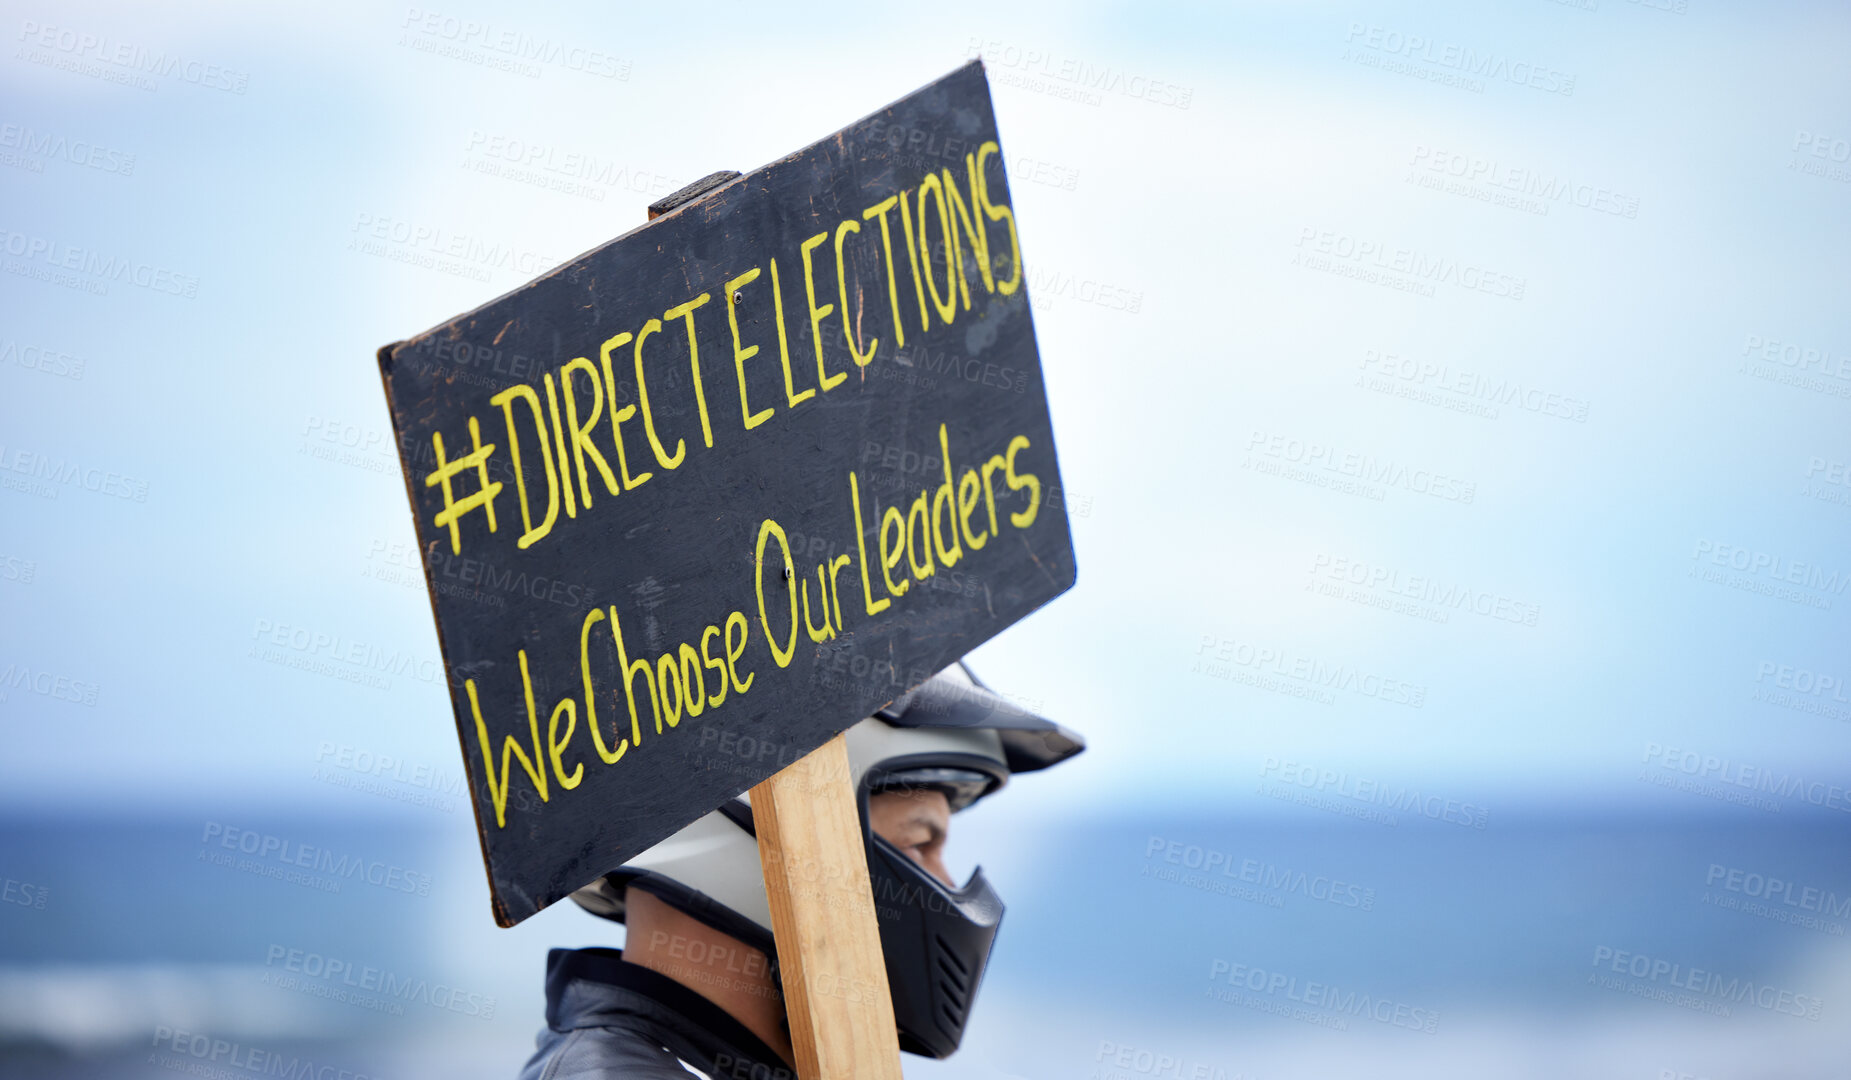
0;0;1851;808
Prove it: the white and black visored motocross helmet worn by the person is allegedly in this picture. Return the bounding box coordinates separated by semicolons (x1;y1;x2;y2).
572;661;1087;1058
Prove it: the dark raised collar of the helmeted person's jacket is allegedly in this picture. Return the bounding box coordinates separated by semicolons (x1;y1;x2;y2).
546;948;796;1080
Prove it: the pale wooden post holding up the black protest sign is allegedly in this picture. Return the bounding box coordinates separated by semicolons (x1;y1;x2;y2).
752;735;900;1080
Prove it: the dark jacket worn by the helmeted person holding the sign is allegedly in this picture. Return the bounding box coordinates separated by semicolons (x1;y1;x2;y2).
520;948;796;1080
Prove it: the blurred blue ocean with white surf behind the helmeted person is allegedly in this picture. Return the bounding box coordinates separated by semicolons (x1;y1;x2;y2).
0;808;1851;1080
